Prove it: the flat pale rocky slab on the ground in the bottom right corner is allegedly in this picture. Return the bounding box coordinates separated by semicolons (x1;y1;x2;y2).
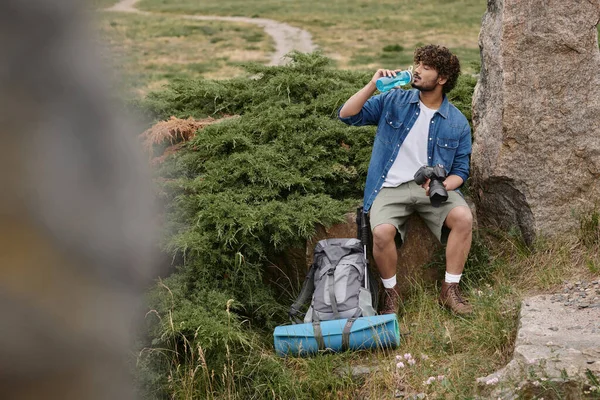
478;280;600;399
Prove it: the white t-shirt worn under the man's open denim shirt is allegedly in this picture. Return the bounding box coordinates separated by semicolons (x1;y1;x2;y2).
383;101;437;187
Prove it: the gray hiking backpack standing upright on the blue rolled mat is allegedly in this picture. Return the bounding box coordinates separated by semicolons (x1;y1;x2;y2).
290;239;376;323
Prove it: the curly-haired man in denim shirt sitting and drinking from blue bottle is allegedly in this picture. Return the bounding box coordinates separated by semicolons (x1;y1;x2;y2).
339;45;473;315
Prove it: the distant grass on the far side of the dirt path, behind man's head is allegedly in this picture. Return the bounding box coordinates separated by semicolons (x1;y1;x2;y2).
139;0;486;72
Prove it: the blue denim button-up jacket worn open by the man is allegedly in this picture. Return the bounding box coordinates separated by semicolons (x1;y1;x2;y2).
338;89;471;212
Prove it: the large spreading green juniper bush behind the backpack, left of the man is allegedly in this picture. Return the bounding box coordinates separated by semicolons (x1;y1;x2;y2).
138;53;472;398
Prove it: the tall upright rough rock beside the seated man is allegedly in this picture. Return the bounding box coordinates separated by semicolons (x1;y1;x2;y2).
472;0;600;243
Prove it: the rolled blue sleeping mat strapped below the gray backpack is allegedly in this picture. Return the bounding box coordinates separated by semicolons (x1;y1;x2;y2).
273;314;400;357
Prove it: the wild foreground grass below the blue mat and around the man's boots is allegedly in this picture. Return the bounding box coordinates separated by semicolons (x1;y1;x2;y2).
136;227;600;400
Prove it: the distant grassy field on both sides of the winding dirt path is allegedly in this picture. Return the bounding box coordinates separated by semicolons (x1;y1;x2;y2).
92;0;486;96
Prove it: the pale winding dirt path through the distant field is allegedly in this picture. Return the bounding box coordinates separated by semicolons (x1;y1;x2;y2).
105;0;316;65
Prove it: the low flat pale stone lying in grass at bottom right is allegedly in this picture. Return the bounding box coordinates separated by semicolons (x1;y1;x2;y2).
477;295;600;399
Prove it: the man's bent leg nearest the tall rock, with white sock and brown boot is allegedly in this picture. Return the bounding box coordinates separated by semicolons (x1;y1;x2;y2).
440;206;473;315
